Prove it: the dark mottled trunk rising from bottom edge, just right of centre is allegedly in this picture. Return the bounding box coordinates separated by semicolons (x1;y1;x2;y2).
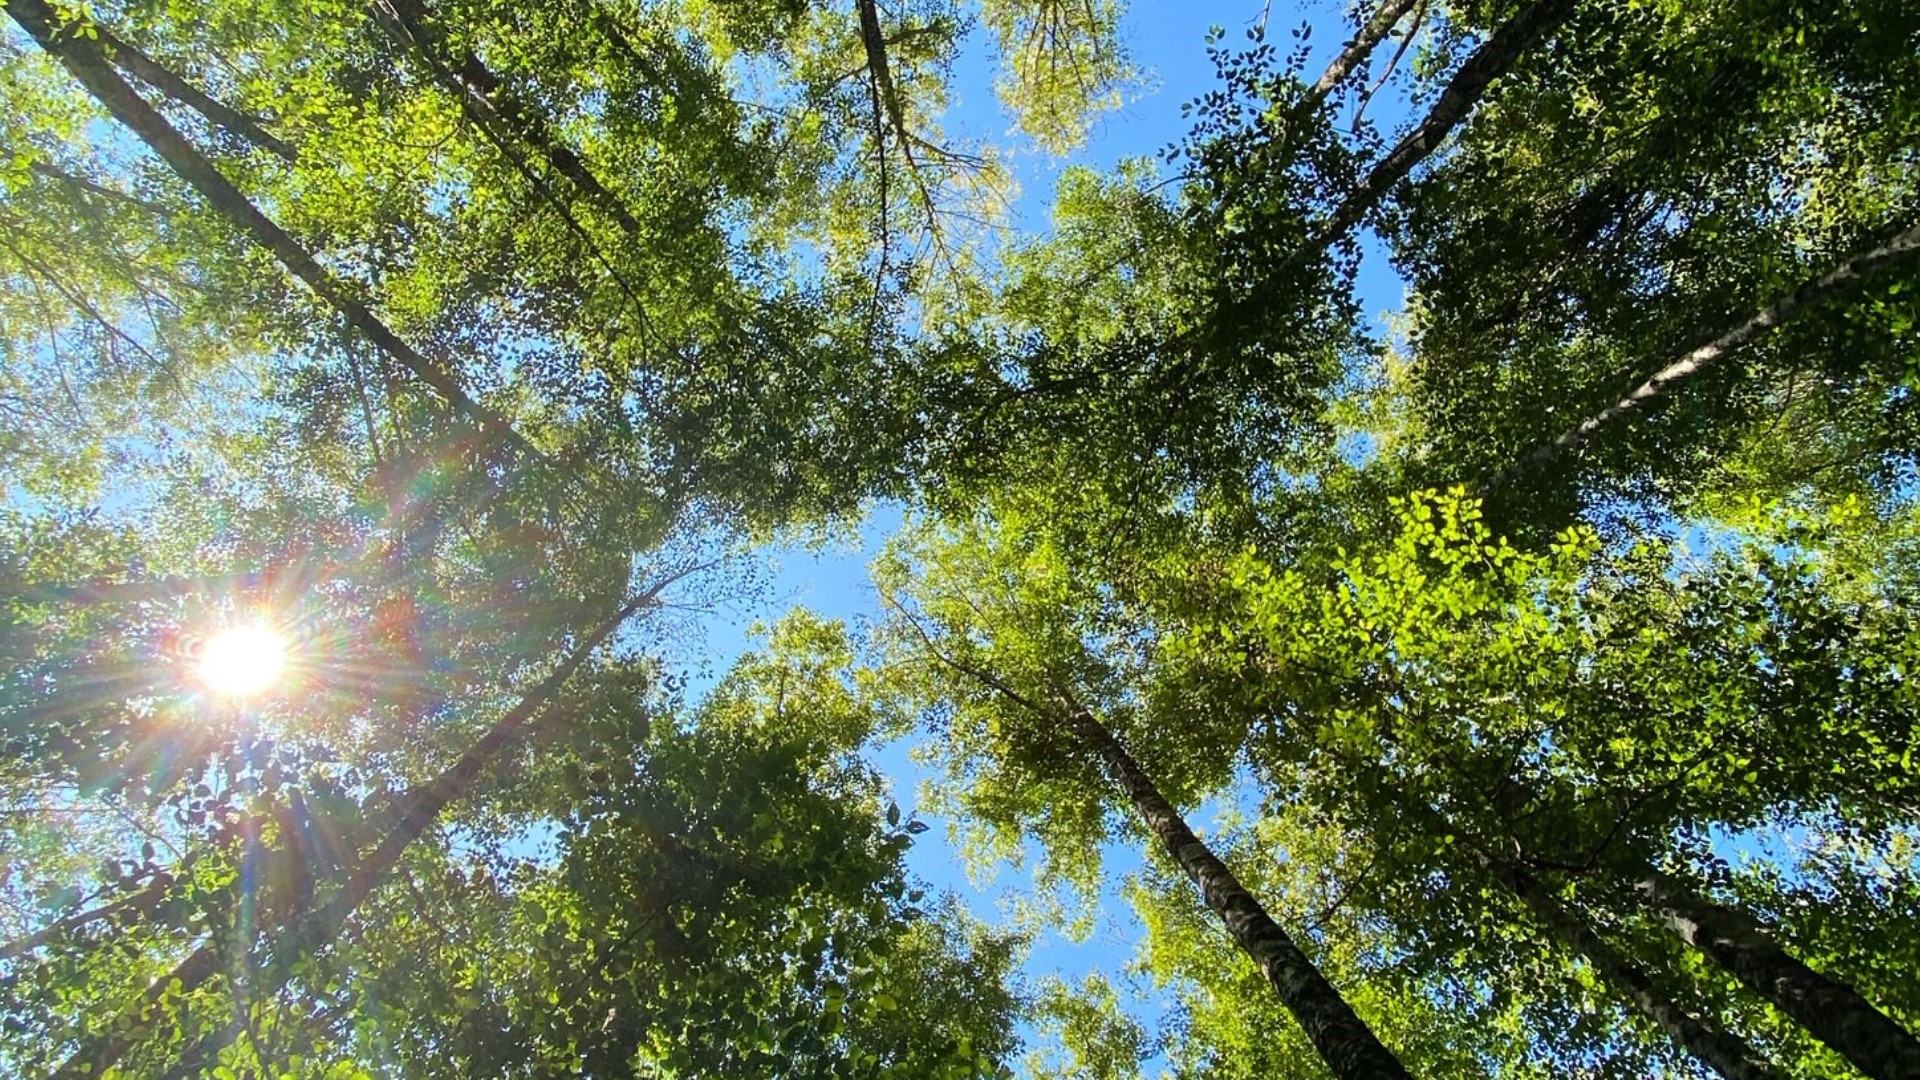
1066;698;1409;1080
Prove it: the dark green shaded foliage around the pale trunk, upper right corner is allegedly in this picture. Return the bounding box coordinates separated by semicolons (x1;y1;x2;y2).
1394;0;1920;521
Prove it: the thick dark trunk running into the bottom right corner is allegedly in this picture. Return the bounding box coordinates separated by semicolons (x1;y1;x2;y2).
1628;865;1920;1080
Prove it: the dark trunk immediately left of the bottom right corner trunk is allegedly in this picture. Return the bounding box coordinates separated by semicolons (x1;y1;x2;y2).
1478;853;1784;1080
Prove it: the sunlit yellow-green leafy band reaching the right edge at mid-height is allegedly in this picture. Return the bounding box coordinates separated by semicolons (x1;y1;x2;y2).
1192;486;1916;828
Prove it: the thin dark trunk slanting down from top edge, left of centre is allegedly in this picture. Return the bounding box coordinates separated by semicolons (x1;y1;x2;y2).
374;0;639;236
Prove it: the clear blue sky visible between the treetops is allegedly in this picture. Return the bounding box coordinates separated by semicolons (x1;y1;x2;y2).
687;0;1428;1072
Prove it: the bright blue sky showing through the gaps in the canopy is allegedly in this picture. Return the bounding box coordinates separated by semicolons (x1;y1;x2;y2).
682;2;1443;1068
